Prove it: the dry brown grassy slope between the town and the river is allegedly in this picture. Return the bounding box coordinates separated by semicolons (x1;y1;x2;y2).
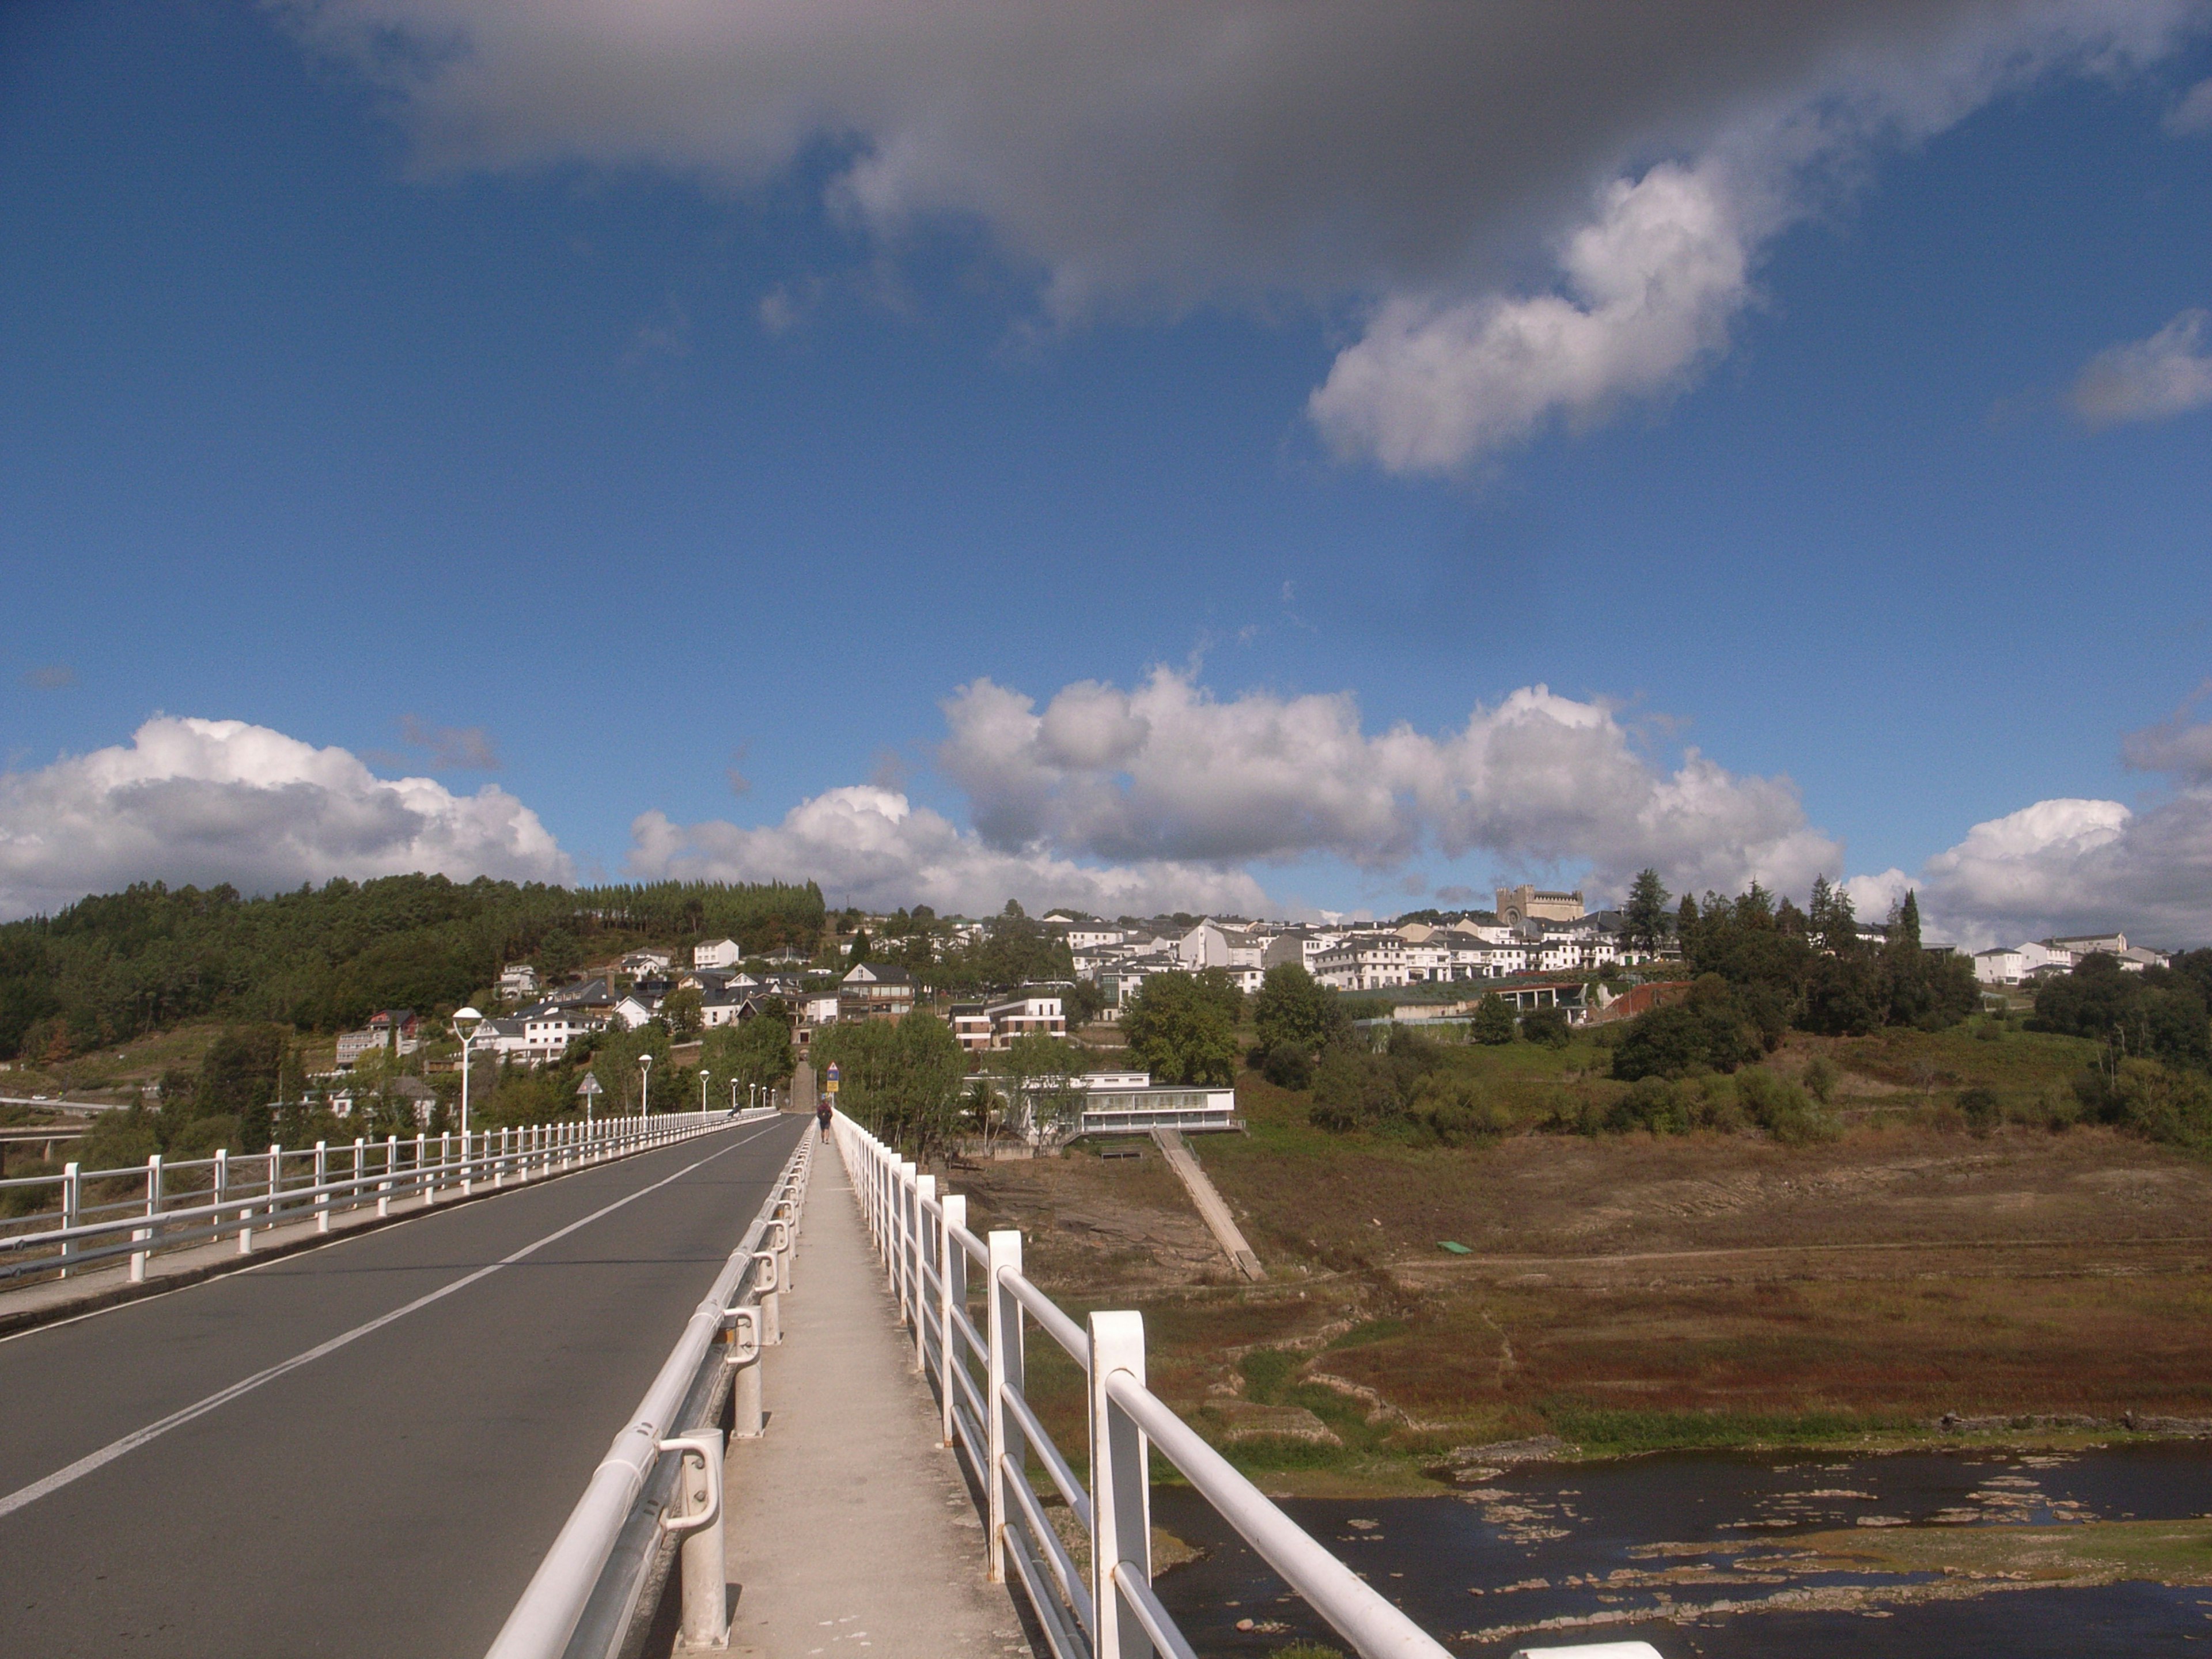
929;1033;2212;1491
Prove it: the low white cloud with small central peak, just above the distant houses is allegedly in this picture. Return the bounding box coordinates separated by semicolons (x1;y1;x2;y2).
628;785;1267;916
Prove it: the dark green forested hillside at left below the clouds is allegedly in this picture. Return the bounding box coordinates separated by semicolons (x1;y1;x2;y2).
0;876;823;1059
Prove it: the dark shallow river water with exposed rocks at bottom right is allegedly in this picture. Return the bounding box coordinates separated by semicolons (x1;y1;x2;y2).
1153;1442;2212;1659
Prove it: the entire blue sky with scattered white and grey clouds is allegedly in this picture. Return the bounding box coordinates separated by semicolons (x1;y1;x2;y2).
0;0;2212;947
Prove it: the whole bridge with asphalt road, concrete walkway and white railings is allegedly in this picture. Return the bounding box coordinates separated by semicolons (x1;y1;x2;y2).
0;1095;1654;1659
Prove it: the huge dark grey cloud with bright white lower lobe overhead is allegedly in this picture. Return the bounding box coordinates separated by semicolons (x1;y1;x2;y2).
276;0;2201;471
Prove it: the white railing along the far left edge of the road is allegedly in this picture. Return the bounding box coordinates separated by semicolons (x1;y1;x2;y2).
0;1113;770;1283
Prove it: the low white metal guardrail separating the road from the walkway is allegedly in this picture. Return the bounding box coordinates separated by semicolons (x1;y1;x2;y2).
487;1113;816;1659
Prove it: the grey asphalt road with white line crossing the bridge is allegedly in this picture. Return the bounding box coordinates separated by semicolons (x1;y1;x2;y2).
0;1117;805;1659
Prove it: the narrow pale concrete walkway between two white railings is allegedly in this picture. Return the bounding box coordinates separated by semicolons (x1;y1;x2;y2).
725;1143;1031;1659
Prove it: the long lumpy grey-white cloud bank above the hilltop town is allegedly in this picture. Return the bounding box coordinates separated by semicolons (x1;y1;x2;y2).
938;668;1840;911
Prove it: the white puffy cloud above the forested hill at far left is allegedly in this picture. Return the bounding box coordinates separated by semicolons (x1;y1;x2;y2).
0;717;571;916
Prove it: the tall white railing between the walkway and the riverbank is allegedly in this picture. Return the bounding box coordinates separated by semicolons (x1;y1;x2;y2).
832;1113;1446;1659
